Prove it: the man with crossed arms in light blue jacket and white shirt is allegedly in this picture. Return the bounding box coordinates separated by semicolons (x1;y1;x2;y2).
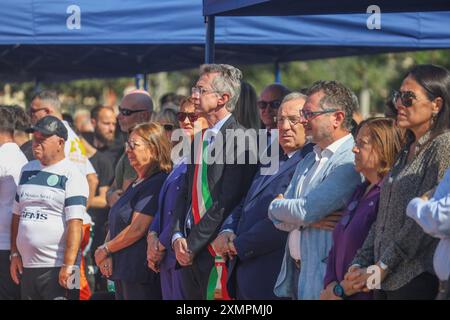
268;81;361;300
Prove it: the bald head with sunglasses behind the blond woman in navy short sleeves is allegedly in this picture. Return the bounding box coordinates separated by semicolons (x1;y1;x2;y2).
117;90;153;132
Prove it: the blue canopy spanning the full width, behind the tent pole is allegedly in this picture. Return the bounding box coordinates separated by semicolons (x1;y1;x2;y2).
0;0;450;81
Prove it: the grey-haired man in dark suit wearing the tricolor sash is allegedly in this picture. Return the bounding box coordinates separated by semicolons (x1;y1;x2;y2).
172;64;257;299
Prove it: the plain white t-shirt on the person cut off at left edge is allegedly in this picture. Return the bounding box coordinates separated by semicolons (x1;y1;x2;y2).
0;142;28;250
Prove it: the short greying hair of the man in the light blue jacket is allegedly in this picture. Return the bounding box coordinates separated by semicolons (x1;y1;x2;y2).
308;80;358;131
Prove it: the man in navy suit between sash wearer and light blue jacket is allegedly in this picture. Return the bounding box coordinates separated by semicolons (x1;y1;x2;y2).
213;92;312;300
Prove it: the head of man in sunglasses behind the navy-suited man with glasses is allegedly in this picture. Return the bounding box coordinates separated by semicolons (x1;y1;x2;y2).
258;83;290;129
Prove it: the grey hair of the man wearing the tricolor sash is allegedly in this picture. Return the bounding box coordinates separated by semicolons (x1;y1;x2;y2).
200;64;242;112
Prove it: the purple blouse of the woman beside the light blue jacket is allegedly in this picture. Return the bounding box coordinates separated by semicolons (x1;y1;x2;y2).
324;180;383;300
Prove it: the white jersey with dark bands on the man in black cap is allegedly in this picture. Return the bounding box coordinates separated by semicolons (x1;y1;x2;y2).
13;158;89;268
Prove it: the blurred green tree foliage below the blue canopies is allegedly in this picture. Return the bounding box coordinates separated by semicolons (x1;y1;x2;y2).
2;50;450;112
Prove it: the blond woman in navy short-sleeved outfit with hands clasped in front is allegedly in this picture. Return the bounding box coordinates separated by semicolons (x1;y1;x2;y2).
95;123;172;300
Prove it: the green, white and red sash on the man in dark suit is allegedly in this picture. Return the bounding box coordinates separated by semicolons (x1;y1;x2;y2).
192;130;230;300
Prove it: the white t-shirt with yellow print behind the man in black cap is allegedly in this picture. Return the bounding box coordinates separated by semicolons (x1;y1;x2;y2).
63;121;95;175
